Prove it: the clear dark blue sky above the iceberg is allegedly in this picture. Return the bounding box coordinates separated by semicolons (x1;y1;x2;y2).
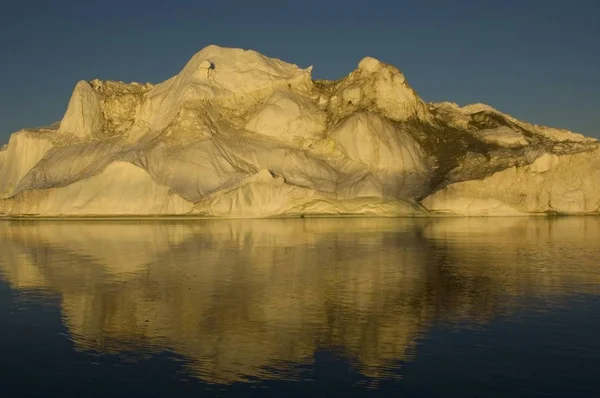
0;0;600;143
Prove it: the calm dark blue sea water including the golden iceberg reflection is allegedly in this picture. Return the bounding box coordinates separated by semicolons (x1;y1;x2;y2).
0;217;600;397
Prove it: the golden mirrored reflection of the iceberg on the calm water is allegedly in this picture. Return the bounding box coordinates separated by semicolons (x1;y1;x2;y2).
0;218;600;383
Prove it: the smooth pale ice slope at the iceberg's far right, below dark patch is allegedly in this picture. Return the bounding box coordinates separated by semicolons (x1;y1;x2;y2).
423;149;600;216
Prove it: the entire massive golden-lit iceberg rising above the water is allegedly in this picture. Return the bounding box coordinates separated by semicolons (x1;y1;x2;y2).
0;46;600;217
